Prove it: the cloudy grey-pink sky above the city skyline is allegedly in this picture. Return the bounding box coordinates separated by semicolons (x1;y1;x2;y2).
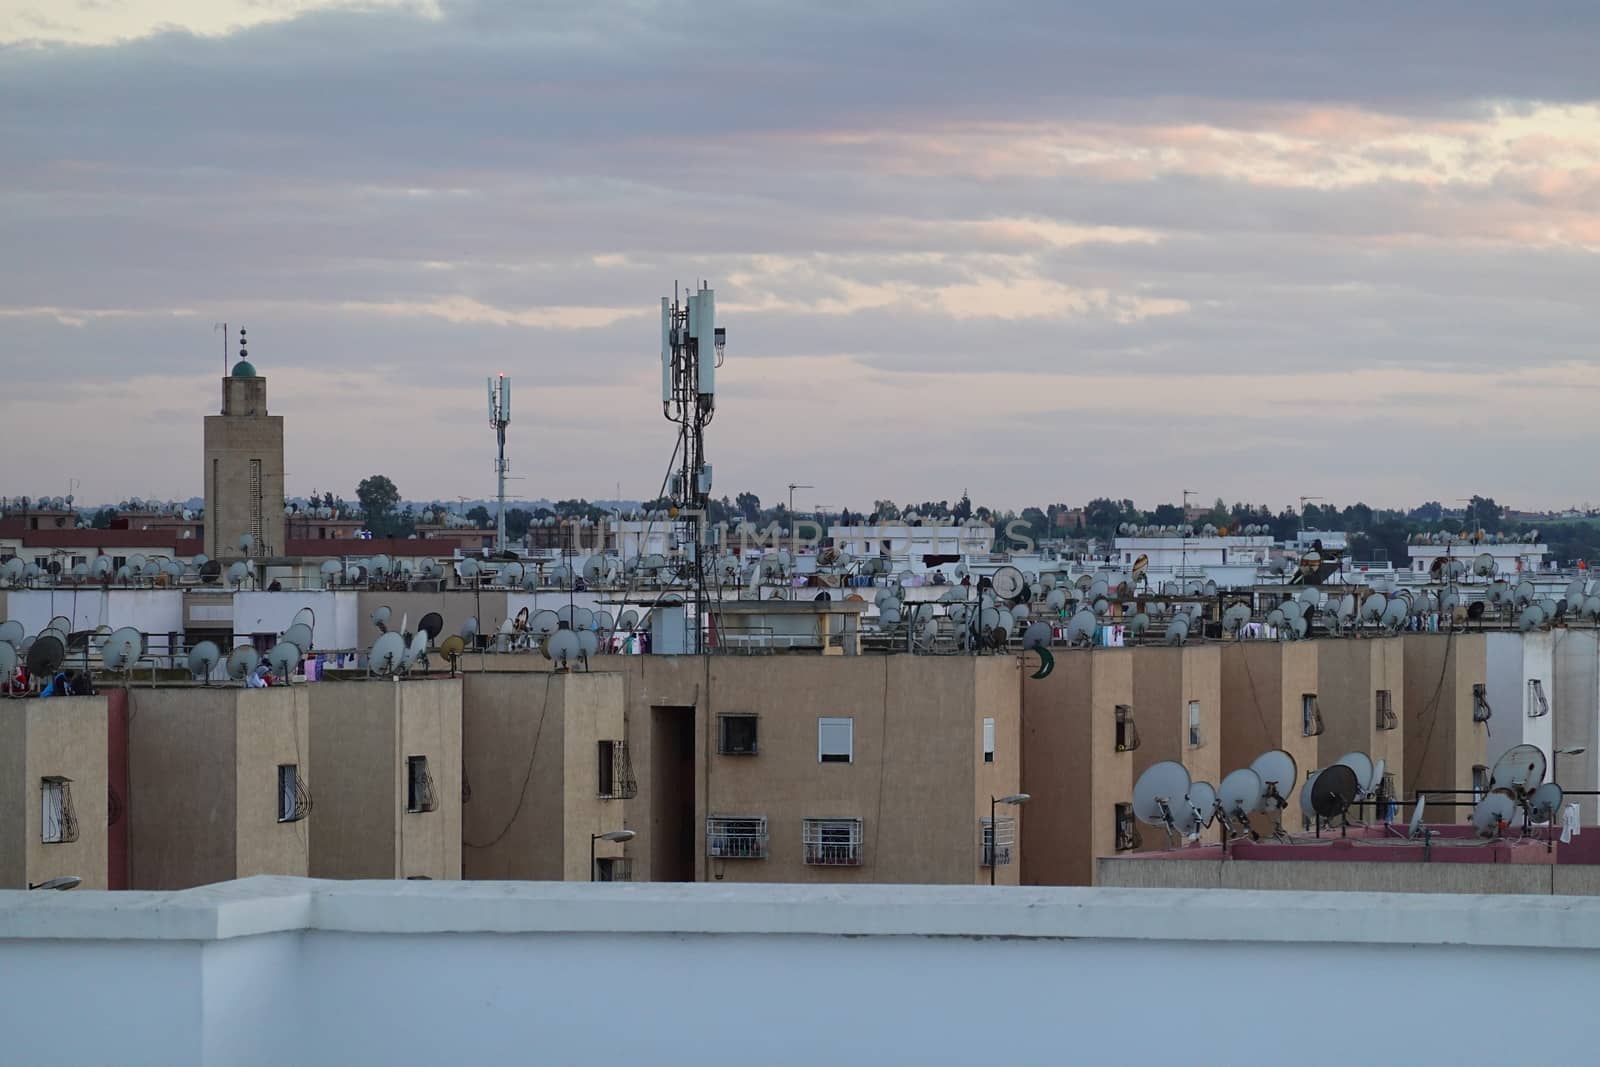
0;0;1600;509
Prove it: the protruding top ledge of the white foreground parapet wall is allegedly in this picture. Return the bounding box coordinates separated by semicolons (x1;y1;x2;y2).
0;878;1600;949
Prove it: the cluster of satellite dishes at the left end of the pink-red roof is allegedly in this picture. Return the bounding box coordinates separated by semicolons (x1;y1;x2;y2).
1133;749;1394;846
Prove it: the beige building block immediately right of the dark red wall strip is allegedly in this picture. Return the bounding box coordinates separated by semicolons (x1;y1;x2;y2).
128;686;308;889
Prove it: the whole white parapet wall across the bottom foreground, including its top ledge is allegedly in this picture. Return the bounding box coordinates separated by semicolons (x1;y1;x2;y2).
0;878;1600;1067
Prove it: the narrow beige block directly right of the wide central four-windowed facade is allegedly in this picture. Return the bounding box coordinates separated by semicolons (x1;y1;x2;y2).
1021;648;1149;885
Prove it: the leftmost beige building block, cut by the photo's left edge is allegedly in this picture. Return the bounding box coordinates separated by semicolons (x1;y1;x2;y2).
0;696;107;889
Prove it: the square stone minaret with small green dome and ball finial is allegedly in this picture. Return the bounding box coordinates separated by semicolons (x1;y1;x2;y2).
205;330;285;561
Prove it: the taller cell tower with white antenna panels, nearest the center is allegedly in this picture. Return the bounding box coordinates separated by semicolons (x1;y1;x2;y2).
661;285;726;653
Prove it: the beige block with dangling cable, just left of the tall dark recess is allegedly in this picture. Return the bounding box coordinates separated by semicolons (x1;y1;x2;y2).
461;672;637;881
